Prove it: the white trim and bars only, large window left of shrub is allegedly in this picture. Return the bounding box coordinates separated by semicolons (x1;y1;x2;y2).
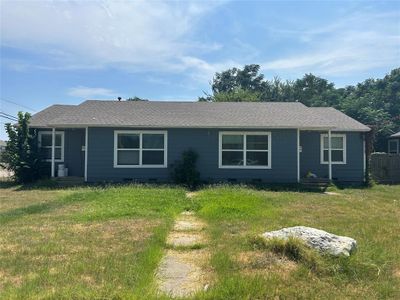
114;130;168;169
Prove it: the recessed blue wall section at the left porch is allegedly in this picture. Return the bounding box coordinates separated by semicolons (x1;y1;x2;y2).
39;128;85;177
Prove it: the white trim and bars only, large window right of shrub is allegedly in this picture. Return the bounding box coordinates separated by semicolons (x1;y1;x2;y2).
218;131;272;169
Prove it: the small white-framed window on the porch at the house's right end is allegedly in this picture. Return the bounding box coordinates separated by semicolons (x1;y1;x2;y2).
321;134;346;165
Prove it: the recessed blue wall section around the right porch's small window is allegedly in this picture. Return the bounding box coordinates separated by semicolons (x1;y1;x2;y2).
300;131;364;182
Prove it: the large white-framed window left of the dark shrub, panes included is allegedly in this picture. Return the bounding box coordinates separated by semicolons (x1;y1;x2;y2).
114;130;167;168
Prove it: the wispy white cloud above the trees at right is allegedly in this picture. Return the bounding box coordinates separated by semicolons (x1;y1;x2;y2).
262;12;400;76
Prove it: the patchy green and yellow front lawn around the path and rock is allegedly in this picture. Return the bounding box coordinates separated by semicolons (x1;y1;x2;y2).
0;185;400;299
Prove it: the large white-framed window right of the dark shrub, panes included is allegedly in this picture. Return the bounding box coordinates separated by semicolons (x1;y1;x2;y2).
219;131;271;169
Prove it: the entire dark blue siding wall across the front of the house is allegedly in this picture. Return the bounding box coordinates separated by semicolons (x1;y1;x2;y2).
36;128;364;183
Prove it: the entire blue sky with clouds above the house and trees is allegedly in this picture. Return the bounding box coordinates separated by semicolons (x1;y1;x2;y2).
0;0;400;139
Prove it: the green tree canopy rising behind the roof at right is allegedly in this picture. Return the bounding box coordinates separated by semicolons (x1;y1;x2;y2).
199;64;400;151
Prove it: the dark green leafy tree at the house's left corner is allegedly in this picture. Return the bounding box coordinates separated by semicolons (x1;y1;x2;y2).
2;112;42;183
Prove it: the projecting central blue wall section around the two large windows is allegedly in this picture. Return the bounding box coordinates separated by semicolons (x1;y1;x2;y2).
88;128;297;182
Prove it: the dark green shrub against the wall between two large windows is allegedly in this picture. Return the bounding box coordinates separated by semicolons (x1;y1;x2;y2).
172;149;200;190
